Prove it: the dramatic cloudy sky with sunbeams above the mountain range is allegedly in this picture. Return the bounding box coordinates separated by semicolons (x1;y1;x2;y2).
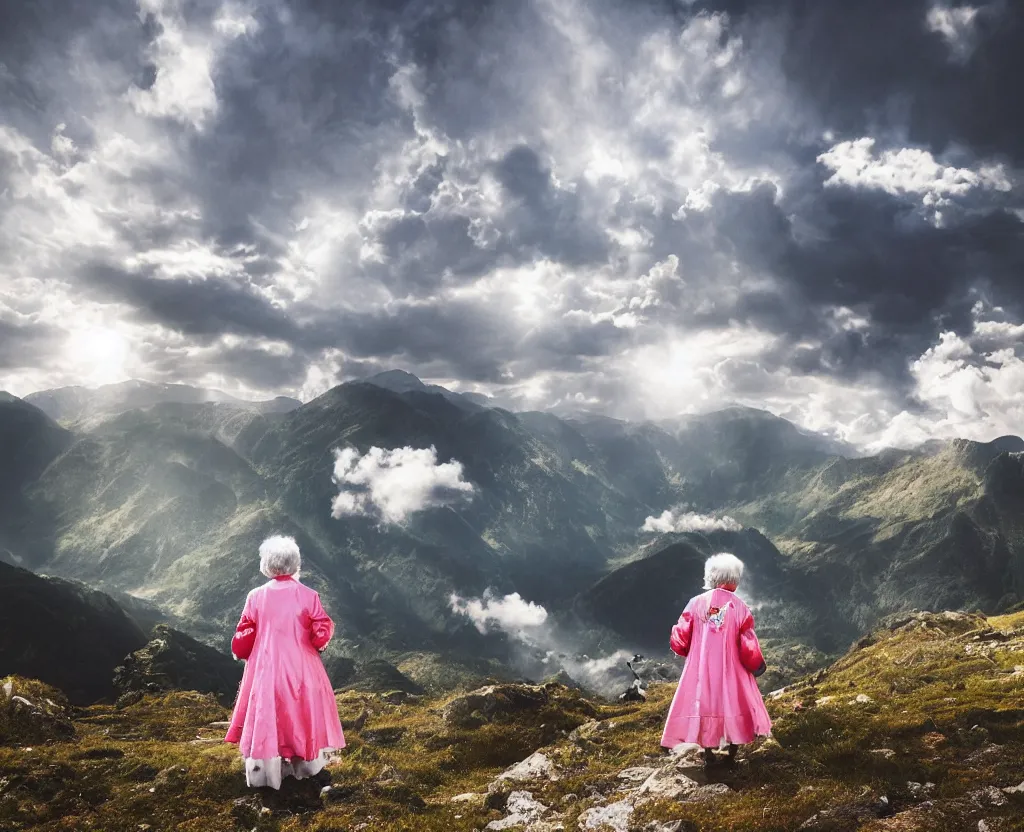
0;0;1024;449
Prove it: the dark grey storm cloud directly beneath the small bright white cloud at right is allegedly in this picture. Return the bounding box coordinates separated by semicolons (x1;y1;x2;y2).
708;169;1024;383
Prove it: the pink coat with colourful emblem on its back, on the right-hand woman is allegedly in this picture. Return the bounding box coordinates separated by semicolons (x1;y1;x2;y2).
662;588;771;748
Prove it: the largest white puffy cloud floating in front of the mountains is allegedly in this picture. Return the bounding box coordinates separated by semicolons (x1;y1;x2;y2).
331;447;476;524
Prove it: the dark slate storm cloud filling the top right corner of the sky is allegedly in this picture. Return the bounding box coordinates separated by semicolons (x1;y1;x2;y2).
699;0;1024;163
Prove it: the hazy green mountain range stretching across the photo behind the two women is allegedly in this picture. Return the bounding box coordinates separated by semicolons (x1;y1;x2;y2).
0;372;1024;696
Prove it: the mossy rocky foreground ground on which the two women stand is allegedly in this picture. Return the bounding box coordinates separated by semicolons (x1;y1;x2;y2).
0;613;1024;832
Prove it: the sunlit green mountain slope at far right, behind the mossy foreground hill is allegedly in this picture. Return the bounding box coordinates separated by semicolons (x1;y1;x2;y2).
724;438;1024;629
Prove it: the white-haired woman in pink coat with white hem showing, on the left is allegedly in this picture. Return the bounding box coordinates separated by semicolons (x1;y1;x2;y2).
224;537;345;789
